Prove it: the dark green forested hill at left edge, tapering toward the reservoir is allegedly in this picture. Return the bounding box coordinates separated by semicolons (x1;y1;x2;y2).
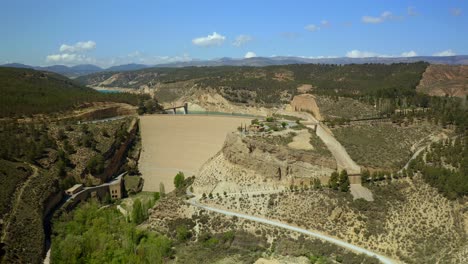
0;67;143;117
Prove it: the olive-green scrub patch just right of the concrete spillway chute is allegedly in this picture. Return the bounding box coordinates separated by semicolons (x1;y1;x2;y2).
332;122;442;170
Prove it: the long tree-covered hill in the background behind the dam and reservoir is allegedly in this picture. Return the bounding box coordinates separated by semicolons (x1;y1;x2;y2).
76;62;428;104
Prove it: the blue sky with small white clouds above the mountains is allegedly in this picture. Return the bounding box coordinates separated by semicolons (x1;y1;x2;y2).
0;0;468;67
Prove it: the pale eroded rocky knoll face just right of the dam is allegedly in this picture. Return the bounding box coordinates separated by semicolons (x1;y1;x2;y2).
194;133;336;193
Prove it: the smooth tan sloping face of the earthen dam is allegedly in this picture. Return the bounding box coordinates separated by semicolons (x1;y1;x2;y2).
139;115;250;192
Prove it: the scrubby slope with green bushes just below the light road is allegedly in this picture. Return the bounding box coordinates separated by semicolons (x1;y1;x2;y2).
149;194;378;264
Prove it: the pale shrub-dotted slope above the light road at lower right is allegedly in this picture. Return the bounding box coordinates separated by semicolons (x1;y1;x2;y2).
205;178;468;263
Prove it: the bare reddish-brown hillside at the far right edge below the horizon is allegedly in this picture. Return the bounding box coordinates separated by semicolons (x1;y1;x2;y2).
417;65;468;98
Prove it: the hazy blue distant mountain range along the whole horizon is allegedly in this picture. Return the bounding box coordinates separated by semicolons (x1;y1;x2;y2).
0;55;468;78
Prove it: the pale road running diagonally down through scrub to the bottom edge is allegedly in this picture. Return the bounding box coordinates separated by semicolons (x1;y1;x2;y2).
188;197;397;264
